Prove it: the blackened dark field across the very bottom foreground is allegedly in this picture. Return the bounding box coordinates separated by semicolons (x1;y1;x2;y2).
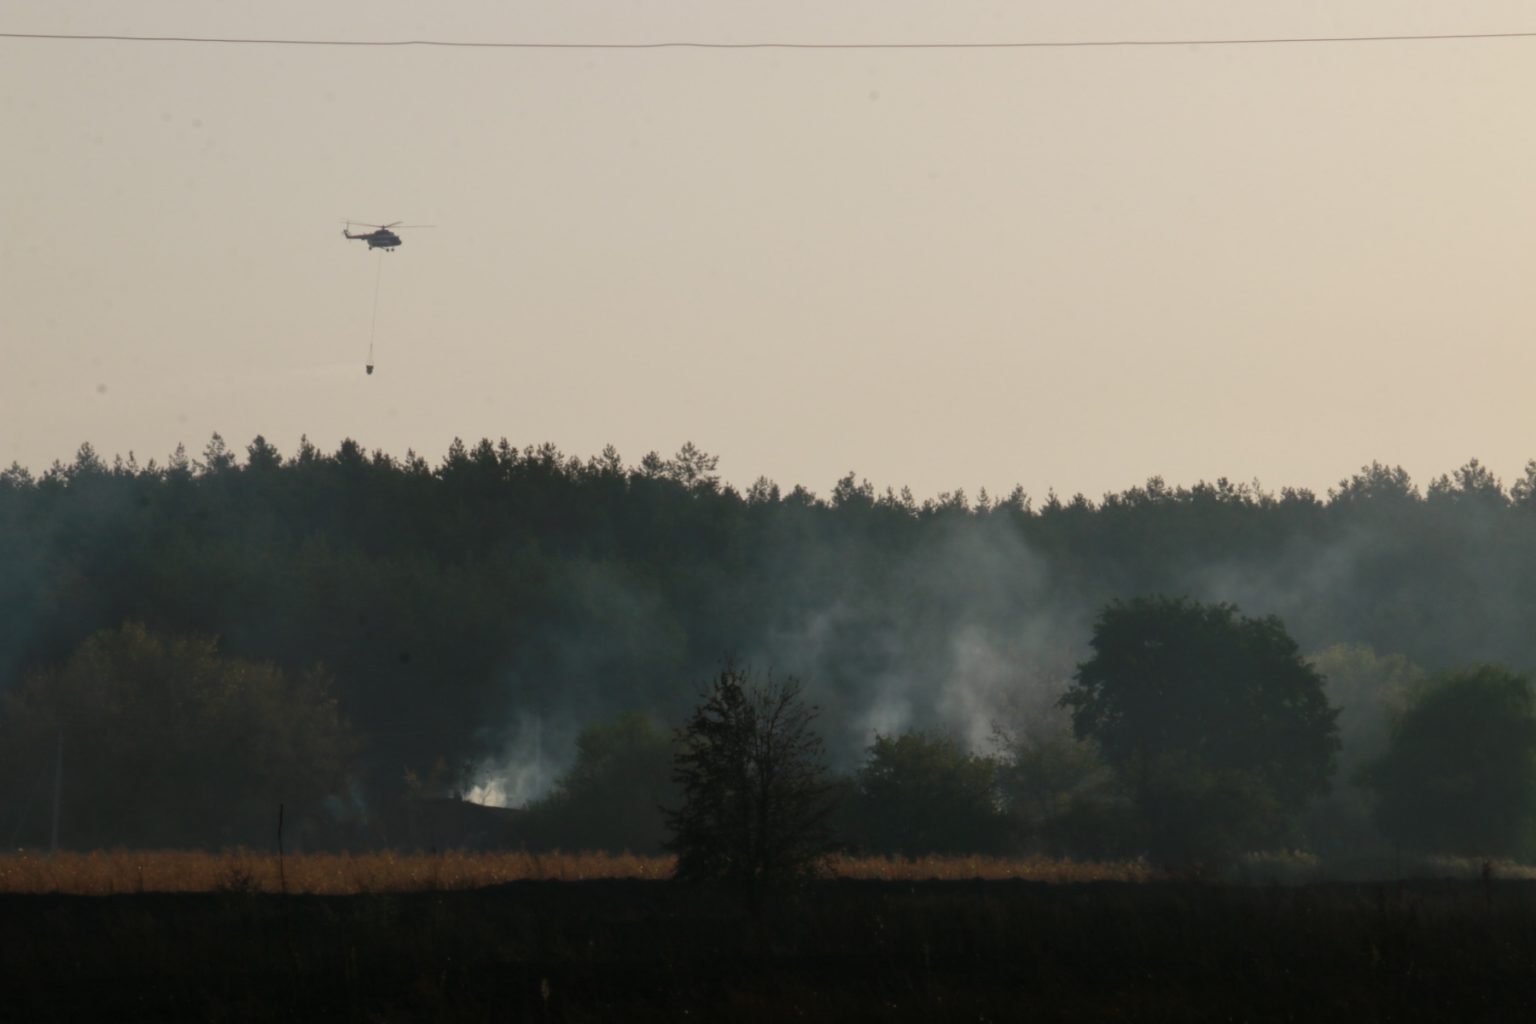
9;880;1536;1021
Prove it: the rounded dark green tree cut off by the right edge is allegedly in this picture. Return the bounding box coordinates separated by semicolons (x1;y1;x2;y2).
1364;665;1536;857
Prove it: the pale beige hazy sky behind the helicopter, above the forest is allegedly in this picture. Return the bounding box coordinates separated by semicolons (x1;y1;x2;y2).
0;0;1536;496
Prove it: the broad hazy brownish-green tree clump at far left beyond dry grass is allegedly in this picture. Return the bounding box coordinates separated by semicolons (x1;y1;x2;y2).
0;623;353;849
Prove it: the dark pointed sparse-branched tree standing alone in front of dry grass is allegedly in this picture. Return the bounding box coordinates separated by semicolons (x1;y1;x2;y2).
667;663;831;897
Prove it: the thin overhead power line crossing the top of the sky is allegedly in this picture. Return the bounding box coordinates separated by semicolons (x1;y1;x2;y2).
0;32;1536;49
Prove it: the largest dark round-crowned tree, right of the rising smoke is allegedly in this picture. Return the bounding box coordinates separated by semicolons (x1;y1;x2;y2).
1061;597;1338;864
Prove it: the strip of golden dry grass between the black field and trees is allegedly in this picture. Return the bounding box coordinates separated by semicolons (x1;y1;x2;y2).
0;851;1154;895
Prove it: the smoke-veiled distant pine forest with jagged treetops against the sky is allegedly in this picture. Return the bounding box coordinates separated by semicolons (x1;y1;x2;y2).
0;434;1536;838
